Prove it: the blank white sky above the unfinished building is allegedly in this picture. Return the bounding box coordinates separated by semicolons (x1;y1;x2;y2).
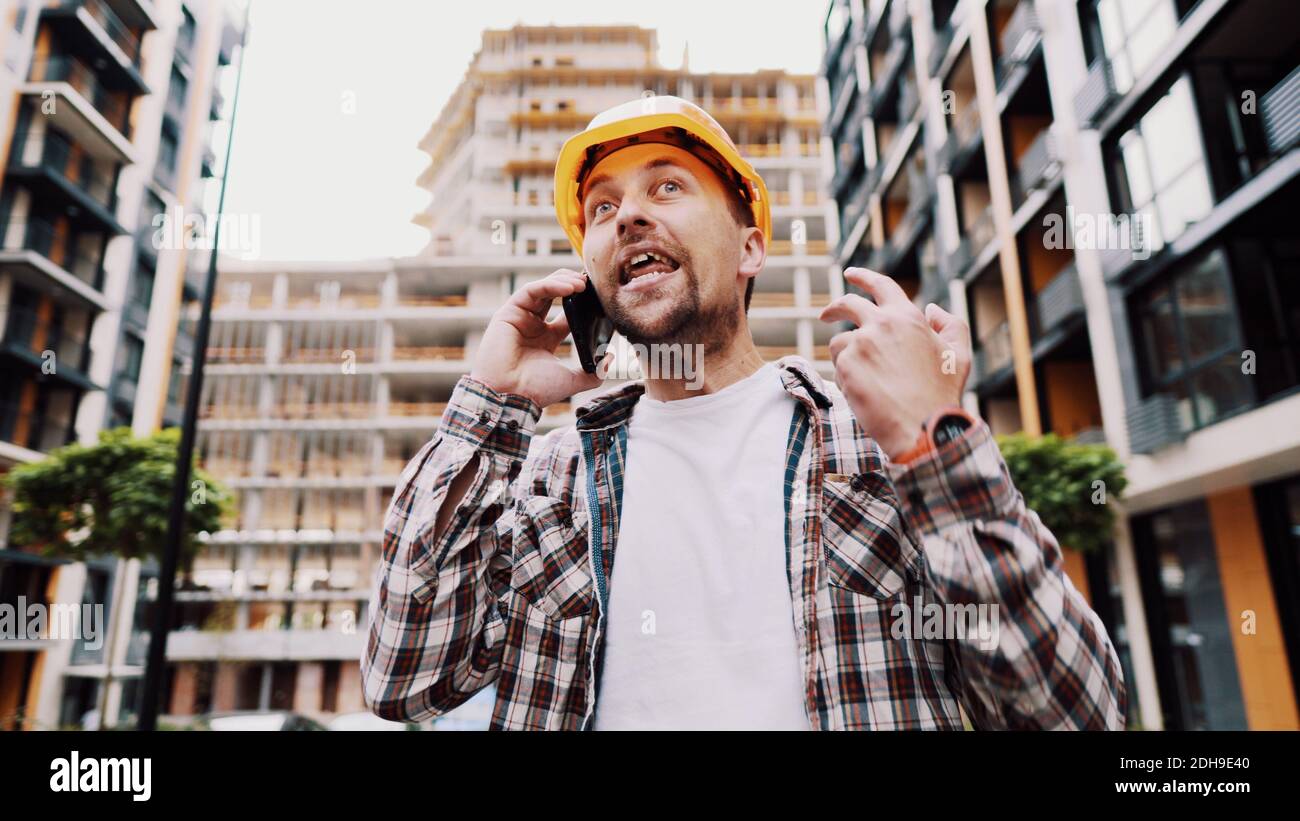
211;0;827;260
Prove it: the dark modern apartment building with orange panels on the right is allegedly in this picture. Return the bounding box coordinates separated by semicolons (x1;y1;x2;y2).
823;0;1300;729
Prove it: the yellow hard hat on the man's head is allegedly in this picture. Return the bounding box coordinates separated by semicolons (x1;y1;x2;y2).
555;95;772;257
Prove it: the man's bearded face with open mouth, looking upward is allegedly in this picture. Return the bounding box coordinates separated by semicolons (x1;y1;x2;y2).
582;143;764;348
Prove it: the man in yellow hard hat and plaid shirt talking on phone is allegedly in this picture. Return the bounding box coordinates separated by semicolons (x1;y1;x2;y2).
361;97;1125;730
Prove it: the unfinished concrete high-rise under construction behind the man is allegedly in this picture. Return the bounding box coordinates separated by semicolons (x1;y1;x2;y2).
175;26;842;714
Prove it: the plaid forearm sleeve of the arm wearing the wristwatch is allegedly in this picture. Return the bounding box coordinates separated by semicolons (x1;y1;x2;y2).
888;420;1126;730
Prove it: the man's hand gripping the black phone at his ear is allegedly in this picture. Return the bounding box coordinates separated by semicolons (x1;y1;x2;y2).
469;268;612;408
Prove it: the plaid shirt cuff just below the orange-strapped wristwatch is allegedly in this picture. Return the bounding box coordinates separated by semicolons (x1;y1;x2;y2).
888;420;1018;534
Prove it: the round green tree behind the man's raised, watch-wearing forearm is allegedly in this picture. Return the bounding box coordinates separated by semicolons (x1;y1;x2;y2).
997;434;1128;553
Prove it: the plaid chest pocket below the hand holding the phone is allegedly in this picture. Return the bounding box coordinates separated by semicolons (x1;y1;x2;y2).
510;496;595;618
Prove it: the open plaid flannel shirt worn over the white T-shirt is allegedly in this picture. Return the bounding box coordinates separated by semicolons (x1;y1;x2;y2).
361;356;1126;730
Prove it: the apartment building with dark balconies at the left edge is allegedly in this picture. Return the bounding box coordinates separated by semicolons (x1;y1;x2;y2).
0;0;242;729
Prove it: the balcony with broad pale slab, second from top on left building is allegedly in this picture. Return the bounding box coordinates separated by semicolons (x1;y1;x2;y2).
22;55;134;164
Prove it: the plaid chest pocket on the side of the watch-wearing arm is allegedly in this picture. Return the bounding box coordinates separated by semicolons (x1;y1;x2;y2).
822;472;920;599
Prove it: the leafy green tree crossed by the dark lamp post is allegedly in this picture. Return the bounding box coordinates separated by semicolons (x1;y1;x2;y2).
0;427;231;568
